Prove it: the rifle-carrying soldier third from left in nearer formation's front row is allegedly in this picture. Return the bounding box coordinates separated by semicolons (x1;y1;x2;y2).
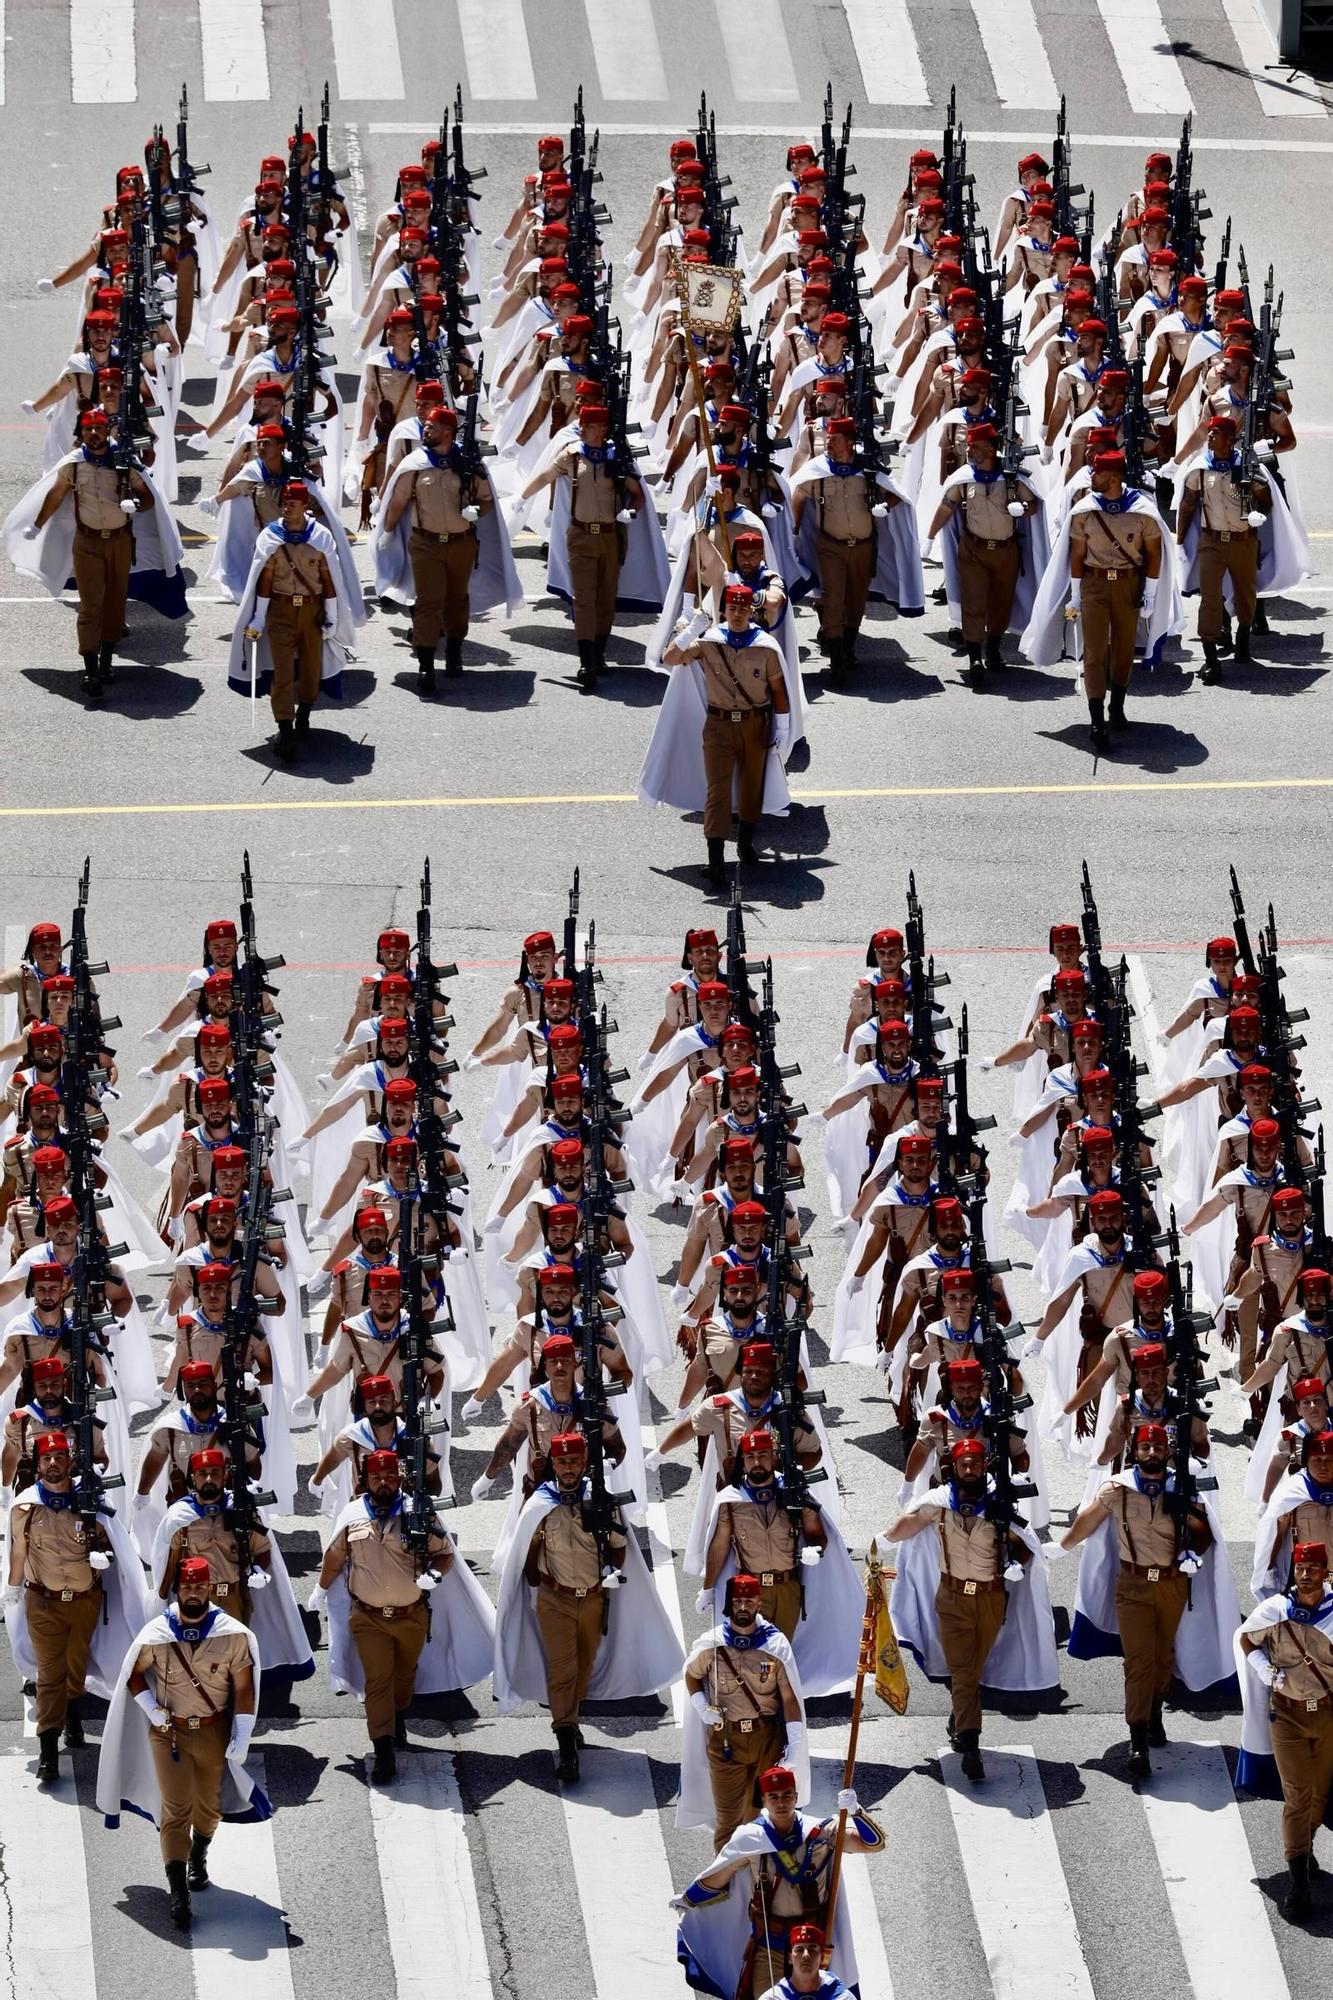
320;1450;454;1784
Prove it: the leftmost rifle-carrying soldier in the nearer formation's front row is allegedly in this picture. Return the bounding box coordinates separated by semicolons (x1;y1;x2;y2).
6;1430;112;1784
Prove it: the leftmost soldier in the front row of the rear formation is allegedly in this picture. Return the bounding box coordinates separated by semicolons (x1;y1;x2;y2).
24;410;154;702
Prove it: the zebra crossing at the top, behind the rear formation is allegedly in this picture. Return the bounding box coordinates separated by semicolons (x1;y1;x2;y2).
0;0;1327;122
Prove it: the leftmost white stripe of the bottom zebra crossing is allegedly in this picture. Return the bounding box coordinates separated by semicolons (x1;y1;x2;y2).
0;1752;98;2000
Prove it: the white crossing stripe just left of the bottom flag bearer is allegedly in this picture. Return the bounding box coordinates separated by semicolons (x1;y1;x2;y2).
560;1742;681;2000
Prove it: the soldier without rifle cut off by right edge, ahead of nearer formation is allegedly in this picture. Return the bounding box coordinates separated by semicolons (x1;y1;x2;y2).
1241;1542;1333;1920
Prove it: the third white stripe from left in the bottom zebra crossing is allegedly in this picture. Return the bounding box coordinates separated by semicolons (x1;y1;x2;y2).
370;1750;490;2000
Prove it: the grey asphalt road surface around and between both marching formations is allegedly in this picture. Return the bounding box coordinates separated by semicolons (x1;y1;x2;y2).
0;11;1333;2000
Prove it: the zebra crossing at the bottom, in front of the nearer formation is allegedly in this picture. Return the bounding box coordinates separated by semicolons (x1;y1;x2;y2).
0;1716;1301;2000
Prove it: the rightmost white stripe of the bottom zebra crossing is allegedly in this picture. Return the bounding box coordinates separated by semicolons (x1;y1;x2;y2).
1139;1744;1287;2000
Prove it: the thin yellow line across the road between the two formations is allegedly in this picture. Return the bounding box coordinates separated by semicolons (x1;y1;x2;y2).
0;776;1333;820
